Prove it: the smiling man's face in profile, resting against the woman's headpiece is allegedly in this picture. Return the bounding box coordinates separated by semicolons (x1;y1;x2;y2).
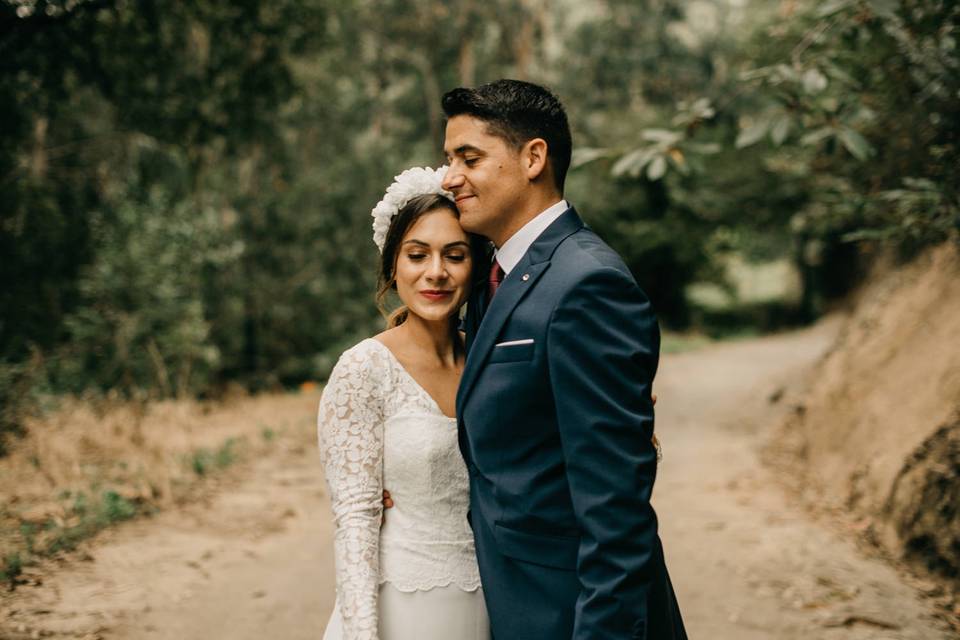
443;115;529;247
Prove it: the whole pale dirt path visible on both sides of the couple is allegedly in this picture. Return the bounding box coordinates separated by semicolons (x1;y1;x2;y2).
0;324;949;640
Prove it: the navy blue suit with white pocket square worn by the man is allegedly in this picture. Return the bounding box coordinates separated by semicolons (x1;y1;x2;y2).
457;208;686;640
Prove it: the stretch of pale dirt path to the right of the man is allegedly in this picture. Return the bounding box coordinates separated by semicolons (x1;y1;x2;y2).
654;322;953;640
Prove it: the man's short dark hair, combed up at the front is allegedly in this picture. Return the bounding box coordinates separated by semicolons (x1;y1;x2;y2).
442;80;573;193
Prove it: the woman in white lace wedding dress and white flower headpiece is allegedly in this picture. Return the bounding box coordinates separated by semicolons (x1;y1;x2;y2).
318;168;490;640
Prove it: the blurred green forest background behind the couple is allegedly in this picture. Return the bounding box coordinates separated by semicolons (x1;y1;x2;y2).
0;0;960;450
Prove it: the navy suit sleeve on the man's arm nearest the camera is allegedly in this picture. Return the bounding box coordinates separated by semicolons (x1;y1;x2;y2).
547;267;660;640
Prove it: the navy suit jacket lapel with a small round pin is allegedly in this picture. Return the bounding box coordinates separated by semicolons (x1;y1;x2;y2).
457;207;583;416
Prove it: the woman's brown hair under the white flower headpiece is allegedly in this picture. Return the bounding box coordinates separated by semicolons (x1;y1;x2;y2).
377;193;487;329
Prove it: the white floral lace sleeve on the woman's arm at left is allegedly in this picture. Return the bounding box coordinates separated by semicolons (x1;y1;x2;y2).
317;349;383;640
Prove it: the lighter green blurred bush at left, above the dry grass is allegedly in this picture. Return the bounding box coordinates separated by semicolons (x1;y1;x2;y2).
55;195;241;397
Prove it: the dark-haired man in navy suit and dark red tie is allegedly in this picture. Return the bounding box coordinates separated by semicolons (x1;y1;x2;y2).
443;80;686;640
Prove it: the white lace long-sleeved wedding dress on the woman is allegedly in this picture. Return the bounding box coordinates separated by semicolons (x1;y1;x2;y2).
318;338;490;640
